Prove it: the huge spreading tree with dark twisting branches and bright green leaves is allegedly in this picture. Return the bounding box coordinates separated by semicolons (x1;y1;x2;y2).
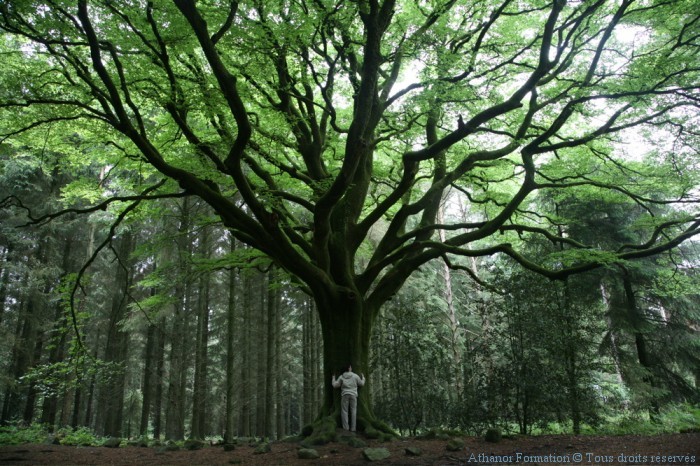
0;0;700;434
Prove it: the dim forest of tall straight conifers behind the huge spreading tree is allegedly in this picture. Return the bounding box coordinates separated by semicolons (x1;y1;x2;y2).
0;150;700;439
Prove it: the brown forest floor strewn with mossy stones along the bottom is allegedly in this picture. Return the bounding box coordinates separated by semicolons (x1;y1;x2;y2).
0;433;700;466
